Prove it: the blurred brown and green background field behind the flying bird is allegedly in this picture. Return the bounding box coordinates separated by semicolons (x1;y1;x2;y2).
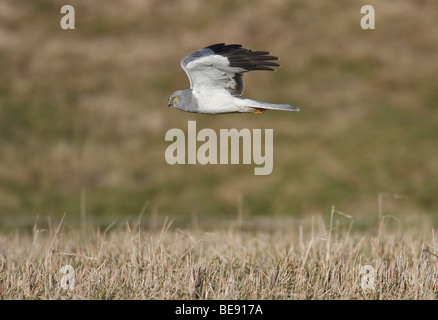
0;0;438;225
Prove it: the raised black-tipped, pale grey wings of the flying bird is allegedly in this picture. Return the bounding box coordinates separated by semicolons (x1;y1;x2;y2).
181;43;279;96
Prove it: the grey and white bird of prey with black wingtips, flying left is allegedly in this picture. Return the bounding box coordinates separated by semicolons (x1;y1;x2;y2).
168;43;300;114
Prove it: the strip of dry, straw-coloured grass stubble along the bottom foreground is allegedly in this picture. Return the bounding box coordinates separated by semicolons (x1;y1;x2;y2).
0;208;438;300
